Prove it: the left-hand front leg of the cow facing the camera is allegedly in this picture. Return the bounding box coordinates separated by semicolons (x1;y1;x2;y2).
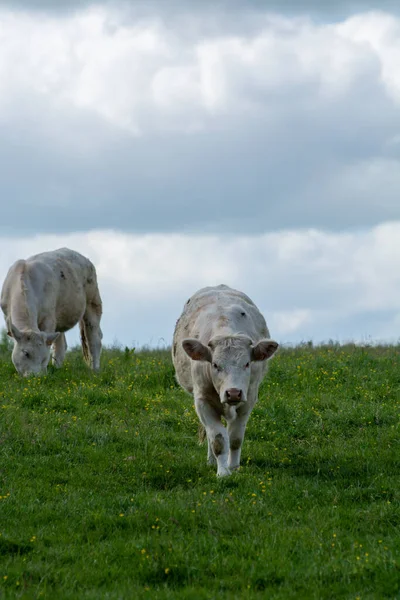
194;397;231;477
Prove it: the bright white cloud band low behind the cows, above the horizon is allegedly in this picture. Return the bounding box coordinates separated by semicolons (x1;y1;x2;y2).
0;222;400;345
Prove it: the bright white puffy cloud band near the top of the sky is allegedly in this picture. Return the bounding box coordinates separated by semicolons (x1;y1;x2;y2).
0;5;400;134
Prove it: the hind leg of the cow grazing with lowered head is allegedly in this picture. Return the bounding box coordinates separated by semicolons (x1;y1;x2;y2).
79;297;103;371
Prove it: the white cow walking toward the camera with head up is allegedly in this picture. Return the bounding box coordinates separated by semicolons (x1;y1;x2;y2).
172;285;278;477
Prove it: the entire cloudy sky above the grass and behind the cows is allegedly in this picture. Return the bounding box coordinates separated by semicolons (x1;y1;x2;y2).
0;0;400;346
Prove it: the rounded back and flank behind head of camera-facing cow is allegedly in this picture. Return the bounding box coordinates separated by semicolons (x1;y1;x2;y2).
172;285;269;392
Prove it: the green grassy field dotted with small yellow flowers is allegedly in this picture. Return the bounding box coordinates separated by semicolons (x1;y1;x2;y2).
0;345;400;600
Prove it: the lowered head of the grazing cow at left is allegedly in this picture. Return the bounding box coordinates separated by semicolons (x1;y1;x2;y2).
7;319;60;377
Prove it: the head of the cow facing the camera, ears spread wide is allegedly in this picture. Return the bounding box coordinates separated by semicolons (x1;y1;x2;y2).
182;335;278;405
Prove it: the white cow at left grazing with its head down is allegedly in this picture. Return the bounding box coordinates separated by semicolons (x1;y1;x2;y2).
1;248;103;377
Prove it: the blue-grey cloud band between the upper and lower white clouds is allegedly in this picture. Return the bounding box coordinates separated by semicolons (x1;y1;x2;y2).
0;83;400;234
